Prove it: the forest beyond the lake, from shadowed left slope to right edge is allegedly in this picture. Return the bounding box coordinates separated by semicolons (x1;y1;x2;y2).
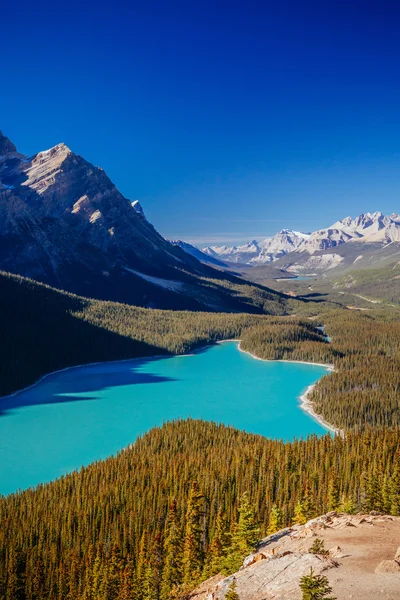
0;275;400;430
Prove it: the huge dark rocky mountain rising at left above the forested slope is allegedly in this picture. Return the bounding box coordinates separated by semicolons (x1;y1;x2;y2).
0;133;280;312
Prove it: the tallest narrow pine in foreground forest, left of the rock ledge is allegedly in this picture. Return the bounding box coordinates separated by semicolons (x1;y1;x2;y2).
182;481;204;586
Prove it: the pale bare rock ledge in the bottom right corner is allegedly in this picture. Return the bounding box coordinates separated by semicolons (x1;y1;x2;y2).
191;513;400;600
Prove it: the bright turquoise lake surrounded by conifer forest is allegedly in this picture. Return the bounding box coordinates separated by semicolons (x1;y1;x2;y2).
0;342;327;494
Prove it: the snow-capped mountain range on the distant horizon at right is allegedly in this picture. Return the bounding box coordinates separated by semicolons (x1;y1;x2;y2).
202;212;400;265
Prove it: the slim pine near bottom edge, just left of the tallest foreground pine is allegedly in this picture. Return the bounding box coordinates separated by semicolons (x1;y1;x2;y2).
160;500;183;600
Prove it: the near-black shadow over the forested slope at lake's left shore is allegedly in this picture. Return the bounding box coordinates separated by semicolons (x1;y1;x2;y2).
0;272;168;404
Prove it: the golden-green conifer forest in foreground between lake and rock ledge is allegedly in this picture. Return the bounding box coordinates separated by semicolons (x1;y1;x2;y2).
0;420;400;600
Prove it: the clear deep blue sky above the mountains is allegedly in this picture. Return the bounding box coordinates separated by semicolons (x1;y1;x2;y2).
0;0;400;245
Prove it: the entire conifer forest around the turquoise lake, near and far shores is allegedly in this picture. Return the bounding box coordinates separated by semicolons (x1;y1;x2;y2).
0;275;400;600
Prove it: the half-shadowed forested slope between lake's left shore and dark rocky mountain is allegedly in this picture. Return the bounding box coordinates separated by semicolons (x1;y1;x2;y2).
0;272;276;396
